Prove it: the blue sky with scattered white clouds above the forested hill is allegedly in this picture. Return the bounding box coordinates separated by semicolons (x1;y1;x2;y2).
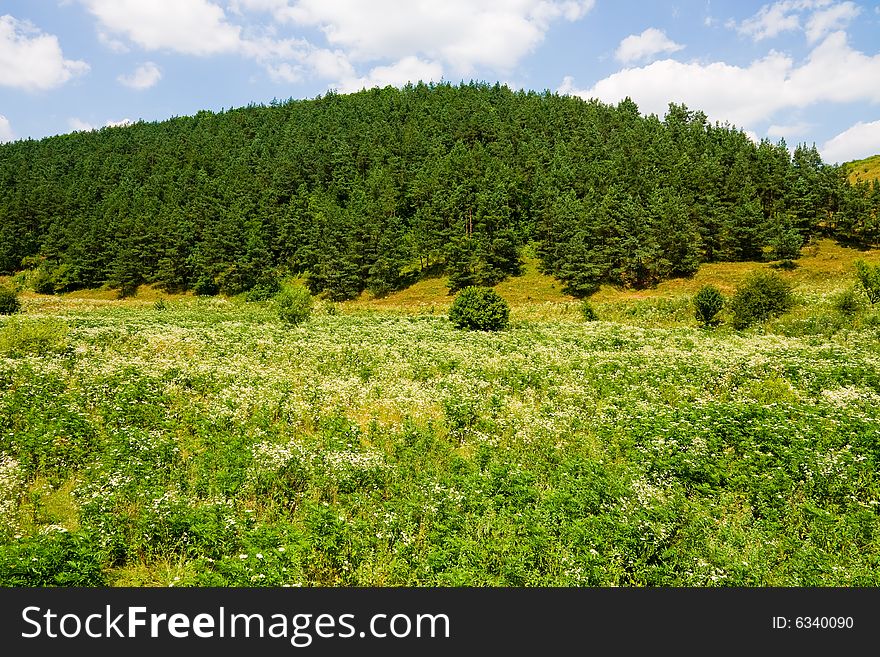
0;0;880;162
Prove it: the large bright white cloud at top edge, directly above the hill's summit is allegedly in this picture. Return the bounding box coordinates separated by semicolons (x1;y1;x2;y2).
278;0;593;75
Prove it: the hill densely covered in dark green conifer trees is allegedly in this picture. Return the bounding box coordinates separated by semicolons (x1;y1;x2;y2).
0;83;880;299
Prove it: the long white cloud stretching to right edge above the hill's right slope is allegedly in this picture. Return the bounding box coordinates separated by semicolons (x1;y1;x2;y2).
559;32;880;128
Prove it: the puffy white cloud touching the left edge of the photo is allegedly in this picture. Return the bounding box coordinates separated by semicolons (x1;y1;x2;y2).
0;15;89;91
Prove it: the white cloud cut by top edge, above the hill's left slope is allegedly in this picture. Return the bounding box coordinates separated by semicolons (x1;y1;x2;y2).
80;0;241;55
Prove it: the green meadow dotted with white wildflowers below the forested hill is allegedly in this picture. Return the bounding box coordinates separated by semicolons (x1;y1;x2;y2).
0;250;880;586
